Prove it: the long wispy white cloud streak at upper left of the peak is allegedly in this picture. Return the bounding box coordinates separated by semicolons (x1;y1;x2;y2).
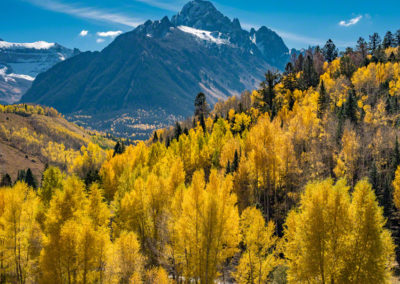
26;0;143;27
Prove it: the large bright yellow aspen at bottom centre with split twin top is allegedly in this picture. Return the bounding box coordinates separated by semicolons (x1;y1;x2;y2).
175;170;239;283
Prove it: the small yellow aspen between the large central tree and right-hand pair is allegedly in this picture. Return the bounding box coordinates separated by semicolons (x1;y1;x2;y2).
234;207;279;284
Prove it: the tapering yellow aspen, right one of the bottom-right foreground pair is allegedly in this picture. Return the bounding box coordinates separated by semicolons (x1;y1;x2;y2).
341;179;394;284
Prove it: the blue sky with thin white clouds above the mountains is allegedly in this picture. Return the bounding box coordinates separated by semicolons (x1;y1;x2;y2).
0;0;400;51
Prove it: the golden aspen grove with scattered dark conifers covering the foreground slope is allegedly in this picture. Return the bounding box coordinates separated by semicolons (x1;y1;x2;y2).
0;38;400;284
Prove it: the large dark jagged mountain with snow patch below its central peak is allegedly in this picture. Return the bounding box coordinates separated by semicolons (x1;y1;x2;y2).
21;0;289;138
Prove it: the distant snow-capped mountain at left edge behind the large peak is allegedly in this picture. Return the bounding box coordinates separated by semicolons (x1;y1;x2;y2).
0;39;79;104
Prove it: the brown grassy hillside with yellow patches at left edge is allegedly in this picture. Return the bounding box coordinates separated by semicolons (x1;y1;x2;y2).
0;105;113;180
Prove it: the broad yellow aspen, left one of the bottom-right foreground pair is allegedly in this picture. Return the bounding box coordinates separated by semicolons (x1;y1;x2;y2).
284;179;351;283
